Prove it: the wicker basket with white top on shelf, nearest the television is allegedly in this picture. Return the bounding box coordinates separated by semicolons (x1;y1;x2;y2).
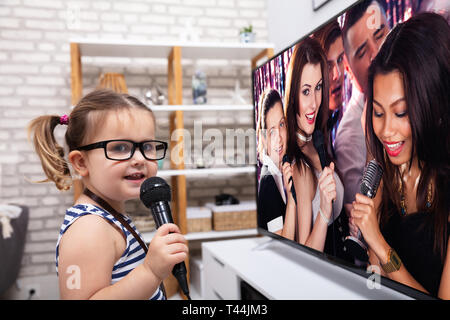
206;201;256;231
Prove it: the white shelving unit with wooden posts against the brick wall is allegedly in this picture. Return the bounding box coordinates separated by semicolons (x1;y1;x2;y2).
70;39;273;298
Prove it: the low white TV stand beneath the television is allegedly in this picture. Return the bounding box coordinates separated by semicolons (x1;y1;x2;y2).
202;236;420;300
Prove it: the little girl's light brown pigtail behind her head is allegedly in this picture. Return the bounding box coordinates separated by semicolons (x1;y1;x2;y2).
28;115;72;190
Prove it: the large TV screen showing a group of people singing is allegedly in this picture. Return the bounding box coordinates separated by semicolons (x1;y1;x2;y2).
253;0;450;297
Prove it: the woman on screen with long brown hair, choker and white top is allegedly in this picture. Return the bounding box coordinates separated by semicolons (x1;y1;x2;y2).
285;38;348;258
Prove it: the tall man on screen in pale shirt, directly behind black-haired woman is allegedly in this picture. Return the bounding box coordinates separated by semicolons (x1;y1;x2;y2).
334;0;389;218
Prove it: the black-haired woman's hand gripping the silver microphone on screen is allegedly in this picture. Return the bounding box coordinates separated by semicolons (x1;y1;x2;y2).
350;193;382;248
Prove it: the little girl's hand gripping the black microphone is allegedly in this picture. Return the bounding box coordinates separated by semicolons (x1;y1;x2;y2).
144;223;189;281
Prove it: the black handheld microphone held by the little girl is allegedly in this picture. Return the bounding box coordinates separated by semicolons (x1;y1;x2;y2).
140;177;191;300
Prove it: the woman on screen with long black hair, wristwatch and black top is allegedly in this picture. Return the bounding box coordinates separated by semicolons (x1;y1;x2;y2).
351;13;450;299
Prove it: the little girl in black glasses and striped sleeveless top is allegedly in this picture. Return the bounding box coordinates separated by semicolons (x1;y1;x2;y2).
28;90;188;299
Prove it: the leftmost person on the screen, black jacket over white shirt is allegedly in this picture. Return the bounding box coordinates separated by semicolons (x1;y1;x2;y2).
256;89;295;240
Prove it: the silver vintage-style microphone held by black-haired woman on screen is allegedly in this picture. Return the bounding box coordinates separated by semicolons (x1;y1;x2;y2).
344;160;383;262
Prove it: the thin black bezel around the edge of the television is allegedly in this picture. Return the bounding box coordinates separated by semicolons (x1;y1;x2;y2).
251;0;438;300
